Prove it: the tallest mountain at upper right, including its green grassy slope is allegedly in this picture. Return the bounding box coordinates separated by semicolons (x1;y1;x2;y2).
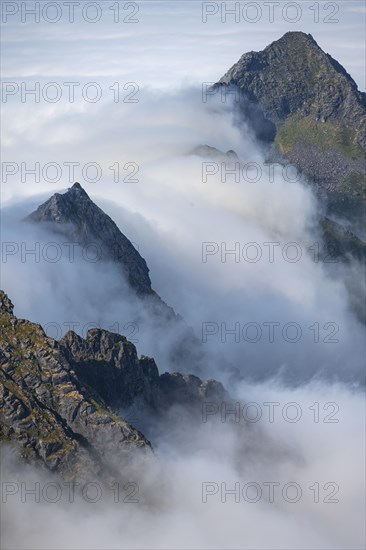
216;32;366;238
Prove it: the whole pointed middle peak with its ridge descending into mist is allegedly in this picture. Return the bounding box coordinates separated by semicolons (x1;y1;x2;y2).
24;182;224;378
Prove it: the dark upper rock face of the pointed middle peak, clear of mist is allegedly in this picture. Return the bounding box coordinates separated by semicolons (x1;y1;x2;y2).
27;183;155;295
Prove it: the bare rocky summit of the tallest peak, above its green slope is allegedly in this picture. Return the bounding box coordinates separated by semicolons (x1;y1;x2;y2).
220;32;366;141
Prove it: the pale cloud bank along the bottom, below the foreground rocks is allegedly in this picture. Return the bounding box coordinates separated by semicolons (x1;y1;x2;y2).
2;385;364;549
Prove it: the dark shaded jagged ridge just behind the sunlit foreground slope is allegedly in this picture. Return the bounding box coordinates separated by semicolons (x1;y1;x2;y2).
60;329;228;413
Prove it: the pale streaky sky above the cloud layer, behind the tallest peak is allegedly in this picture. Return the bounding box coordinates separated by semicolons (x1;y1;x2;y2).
2;0;365;90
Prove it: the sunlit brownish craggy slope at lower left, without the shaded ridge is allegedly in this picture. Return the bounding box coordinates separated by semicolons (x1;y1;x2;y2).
0;291;151;479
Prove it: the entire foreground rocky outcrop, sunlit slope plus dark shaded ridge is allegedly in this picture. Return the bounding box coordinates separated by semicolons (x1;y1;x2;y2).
0;291;227;480
